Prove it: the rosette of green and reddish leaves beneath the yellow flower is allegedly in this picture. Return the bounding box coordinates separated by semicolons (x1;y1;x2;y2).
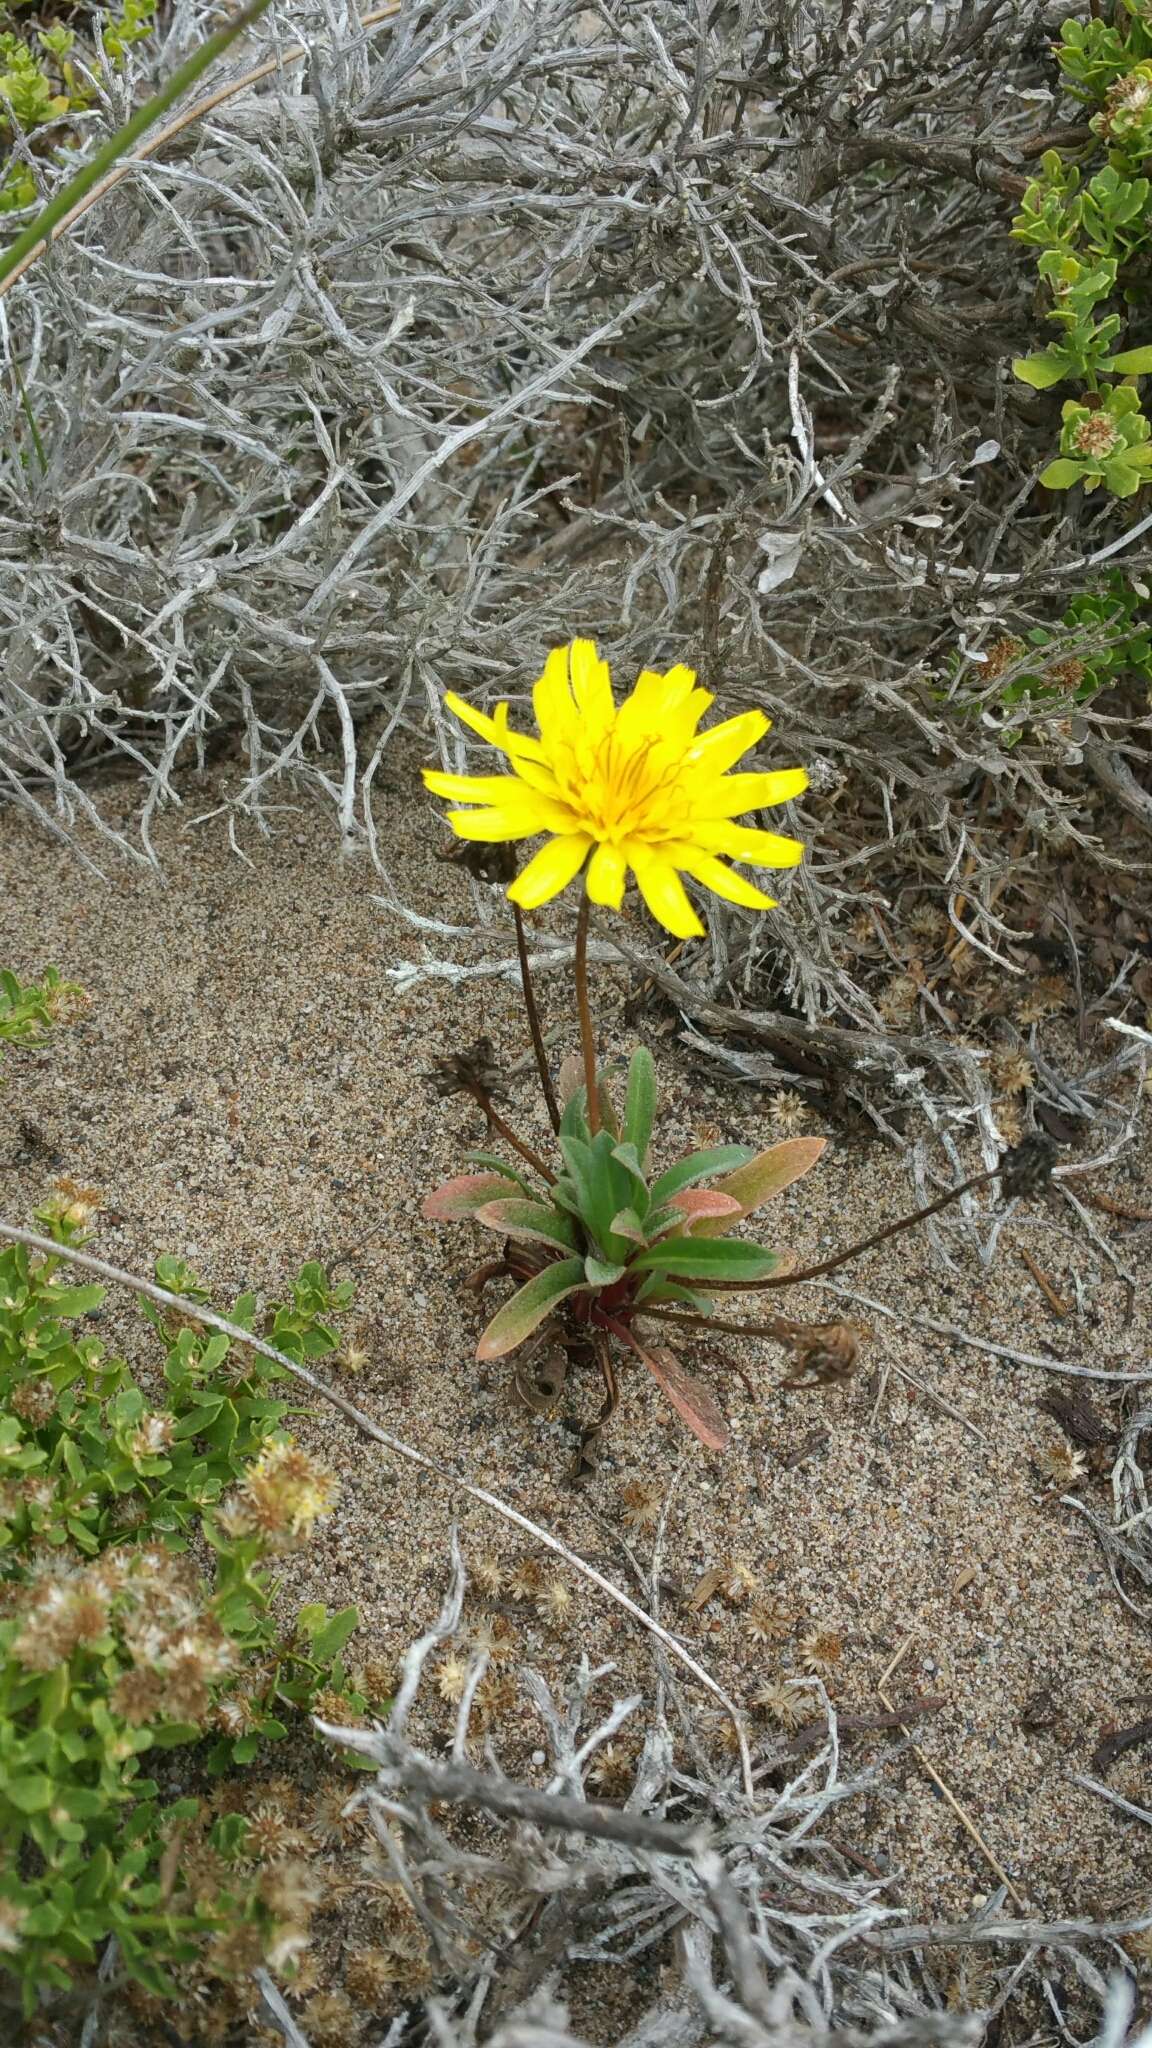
424;1047;826;1450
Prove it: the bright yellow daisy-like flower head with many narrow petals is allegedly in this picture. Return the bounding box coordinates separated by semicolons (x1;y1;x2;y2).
424;641;808;938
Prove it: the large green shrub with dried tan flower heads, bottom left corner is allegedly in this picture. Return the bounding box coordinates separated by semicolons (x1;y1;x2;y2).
0;1196;367;2013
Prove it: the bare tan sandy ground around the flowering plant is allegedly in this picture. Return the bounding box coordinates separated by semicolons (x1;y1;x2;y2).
0;752;1152;1966
